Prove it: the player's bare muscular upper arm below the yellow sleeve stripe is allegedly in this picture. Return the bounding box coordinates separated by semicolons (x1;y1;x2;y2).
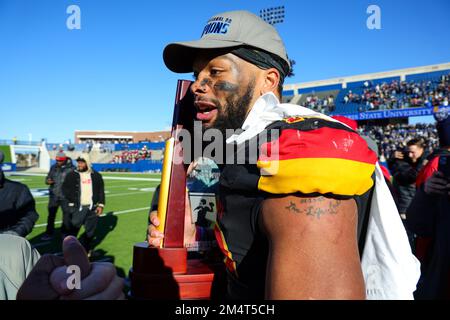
259;196;365;299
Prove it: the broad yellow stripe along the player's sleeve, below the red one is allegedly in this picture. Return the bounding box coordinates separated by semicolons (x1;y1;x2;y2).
258;158;375;196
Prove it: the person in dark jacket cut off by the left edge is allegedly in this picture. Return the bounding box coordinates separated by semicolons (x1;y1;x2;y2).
0;151;39;237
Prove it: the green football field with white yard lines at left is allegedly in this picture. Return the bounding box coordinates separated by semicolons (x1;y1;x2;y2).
8;173;161;276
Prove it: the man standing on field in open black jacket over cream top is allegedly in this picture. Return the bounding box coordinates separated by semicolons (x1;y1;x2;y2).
62;157;105;256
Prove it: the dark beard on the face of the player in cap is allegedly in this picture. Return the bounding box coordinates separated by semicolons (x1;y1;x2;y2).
213;79;255;134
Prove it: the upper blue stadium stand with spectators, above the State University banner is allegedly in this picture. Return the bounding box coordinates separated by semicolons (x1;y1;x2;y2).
283;63;450;115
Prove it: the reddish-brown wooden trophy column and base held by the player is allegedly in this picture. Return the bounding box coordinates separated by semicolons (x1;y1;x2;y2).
130;80;223;299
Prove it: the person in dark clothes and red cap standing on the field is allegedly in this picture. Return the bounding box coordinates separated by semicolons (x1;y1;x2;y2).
41;151;74;241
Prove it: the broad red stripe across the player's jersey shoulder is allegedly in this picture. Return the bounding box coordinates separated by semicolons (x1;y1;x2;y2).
258;127;377;164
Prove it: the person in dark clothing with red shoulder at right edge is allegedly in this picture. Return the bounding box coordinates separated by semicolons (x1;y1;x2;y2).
406;111;450;299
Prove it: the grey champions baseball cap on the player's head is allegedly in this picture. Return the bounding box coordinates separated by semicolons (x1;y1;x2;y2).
163;11;291;73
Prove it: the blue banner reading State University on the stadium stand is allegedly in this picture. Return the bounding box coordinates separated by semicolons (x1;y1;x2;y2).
344;107;443;120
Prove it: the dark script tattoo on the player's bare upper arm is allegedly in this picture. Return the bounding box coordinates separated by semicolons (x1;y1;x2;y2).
285;197;341;219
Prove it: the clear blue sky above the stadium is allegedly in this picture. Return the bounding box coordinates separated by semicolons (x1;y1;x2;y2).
0;0;450;142
